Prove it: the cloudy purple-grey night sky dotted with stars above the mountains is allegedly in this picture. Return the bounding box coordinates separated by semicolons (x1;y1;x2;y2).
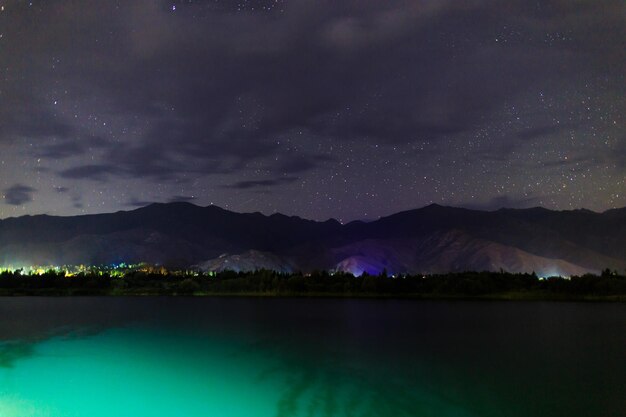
0;0;626;222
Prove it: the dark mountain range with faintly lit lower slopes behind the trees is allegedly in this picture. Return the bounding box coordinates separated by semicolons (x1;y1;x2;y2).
0;203;626;276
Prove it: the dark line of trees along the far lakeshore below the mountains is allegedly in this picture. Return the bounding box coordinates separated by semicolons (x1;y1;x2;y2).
0;269;626;300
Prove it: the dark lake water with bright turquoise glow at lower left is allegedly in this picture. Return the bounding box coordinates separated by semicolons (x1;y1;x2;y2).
0;298;626;417
